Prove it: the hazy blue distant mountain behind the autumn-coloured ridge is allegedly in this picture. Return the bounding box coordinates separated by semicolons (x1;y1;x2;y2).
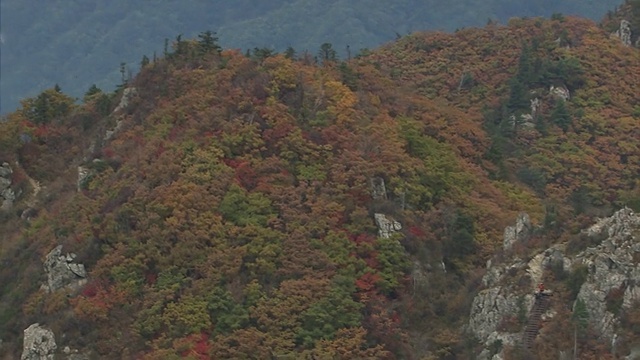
0;0;632;114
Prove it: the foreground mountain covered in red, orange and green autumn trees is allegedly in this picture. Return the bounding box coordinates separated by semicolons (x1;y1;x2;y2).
0;3;640;359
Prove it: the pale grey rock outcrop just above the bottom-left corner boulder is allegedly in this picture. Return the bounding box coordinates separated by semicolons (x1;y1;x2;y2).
44;245;87;292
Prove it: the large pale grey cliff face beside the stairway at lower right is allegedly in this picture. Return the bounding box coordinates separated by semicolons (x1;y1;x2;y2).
469;208;640;358
